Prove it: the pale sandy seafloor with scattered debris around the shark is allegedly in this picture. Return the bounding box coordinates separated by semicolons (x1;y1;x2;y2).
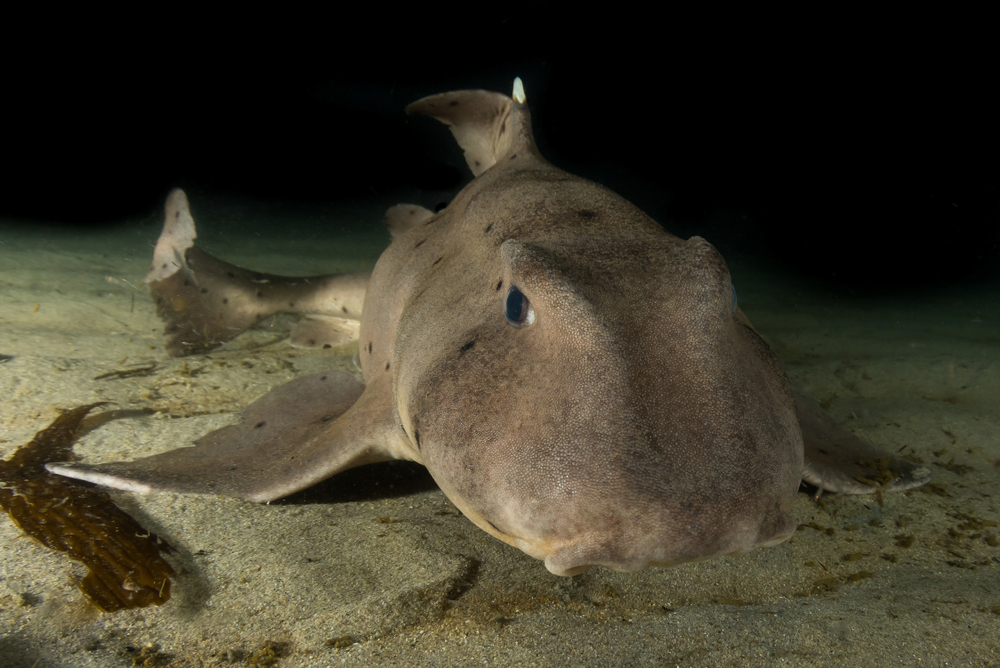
0;193;1000;668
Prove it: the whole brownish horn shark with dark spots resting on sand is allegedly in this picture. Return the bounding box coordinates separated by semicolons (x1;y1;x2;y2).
49;79;930;575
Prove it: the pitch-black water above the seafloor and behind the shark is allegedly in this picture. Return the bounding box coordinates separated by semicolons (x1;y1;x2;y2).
0;9;1000;287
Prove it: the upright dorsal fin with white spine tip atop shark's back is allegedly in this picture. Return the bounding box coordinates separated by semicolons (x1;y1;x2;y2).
406;79;540;176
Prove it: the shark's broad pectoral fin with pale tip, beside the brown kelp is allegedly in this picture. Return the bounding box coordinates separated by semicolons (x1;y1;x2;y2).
47;371;405;502
